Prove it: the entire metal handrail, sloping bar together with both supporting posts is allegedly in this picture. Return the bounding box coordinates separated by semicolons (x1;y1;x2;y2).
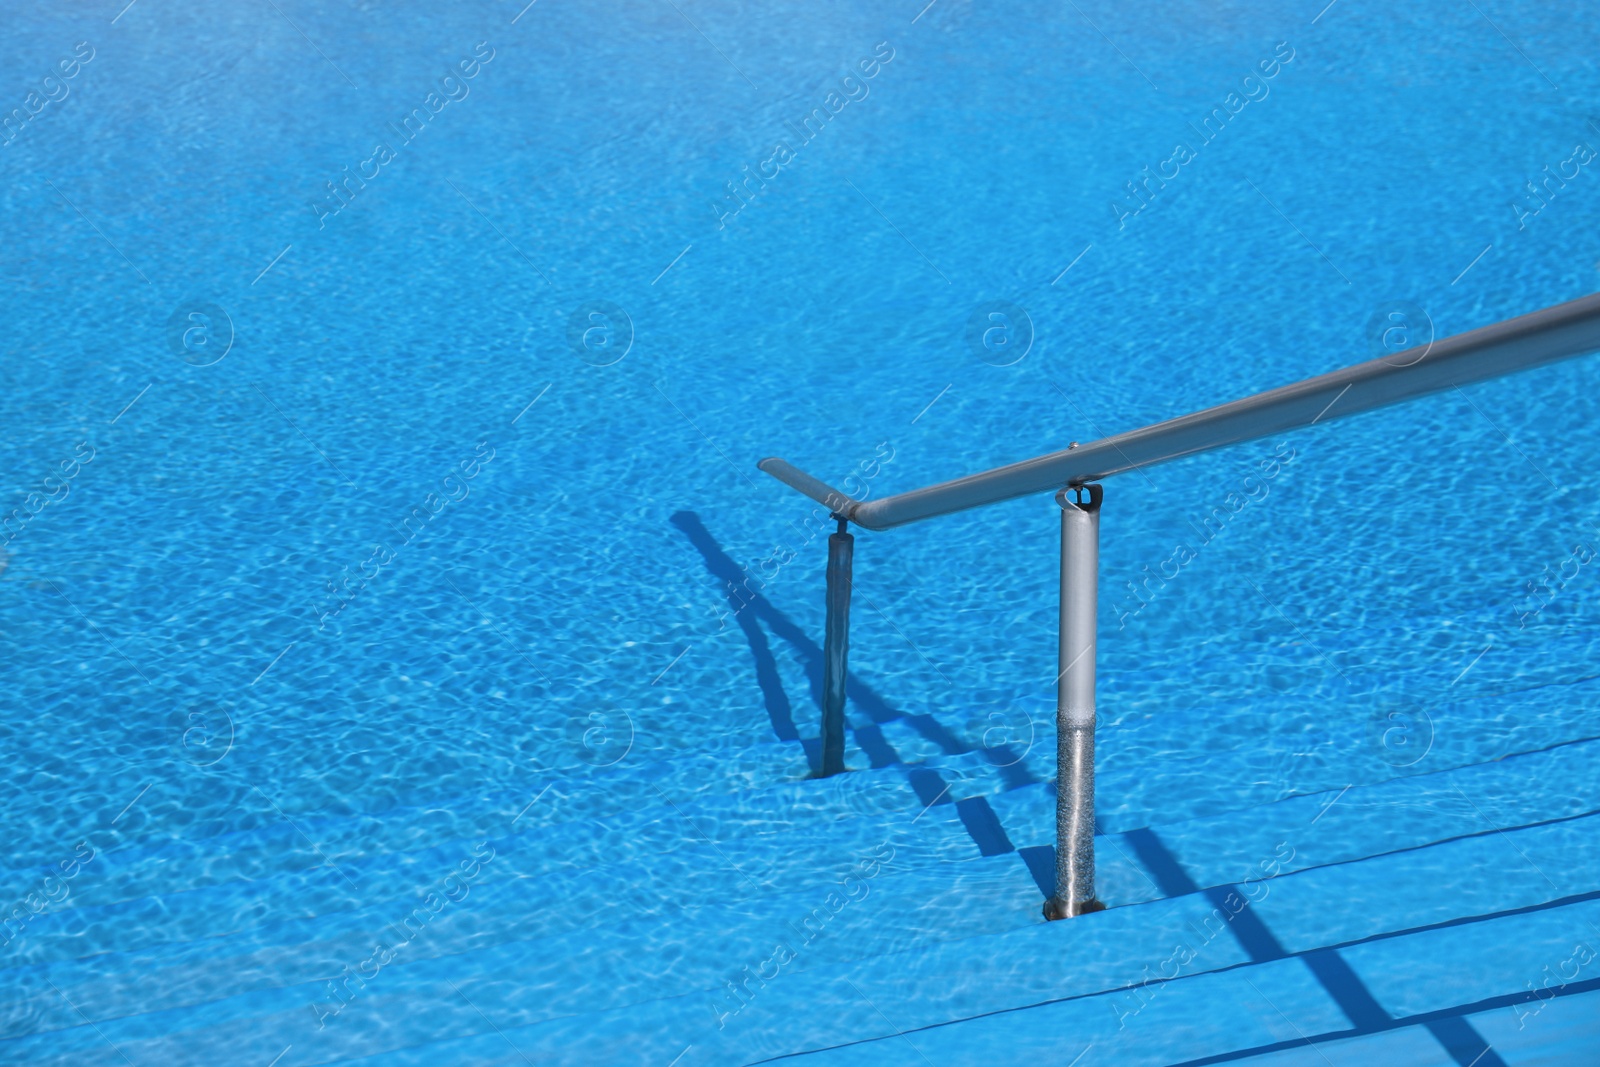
758;293;1600;918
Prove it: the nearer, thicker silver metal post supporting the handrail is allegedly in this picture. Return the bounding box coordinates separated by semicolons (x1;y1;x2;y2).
1045;485;1106;918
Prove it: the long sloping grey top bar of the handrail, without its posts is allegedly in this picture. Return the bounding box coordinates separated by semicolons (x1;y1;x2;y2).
757;293;1600;530
